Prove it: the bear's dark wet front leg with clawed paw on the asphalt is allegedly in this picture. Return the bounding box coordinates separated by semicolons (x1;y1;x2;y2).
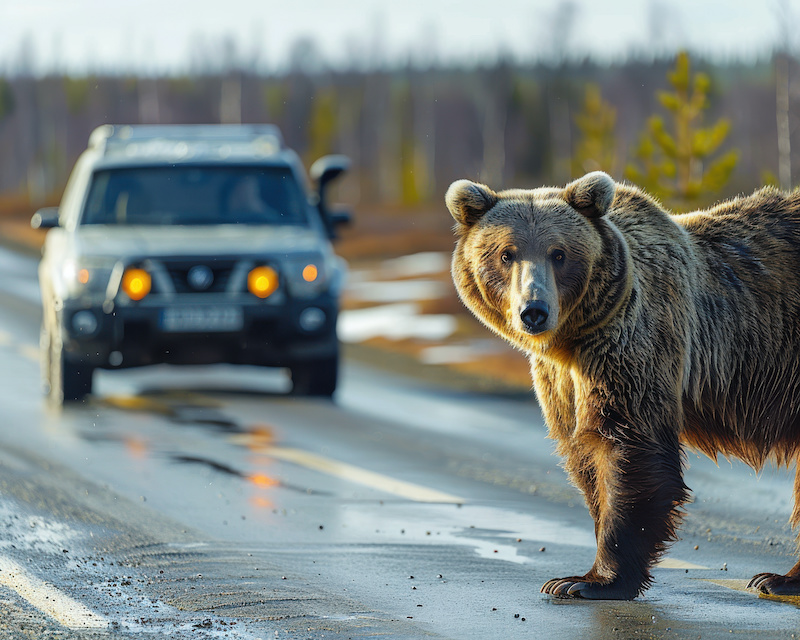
541;424;688;600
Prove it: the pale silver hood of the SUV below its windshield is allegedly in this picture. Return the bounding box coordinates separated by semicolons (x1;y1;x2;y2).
73;225;325;258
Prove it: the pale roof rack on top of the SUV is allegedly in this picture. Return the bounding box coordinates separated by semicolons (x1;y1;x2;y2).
89;124;285;159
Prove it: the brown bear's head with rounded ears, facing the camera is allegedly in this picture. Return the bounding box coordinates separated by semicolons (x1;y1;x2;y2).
445;171;616;351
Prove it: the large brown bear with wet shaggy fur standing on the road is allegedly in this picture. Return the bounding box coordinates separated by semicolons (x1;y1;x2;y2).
446;172;800;599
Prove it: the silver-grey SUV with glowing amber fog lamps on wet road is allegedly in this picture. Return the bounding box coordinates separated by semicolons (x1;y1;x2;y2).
32;125;348;402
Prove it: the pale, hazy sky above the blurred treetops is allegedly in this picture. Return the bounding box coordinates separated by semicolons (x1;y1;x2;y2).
0;0;800;74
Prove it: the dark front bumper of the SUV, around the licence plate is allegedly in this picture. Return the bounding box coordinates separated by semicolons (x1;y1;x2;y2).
59;293;338;369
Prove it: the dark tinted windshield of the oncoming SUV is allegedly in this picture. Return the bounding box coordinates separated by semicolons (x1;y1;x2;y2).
81;166;308;225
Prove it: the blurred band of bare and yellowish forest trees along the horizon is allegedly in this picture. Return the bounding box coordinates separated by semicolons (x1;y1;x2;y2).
0;50;800;232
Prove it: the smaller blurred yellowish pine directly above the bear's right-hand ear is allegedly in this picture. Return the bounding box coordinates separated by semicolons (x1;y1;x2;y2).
572;84;617;178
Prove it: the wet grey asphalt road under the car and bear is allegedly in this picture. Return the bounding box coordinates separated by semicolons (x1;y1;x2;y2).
0;242;800;640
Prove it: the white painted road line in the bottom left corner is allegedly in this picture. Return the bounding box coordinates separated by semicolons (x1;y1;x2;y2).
0;556;108;629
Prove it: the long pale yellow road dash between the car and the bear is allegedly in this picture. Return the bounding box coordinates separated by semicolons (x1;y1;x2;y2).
232;436;465;504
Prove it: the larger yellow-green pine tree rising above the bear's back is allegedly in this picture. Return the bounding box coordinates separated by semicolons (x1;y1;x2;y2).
625;52;739;208
